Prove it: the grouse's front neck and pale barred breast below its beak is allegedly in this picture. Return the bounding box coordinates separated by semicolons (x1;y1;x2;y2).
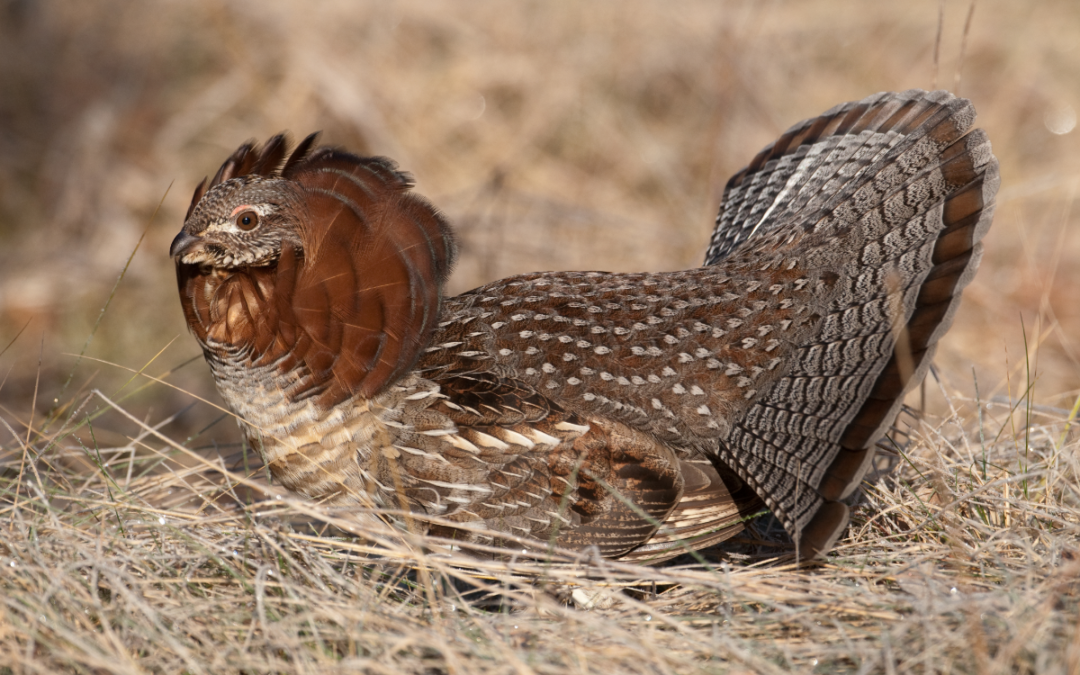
181;262;449;507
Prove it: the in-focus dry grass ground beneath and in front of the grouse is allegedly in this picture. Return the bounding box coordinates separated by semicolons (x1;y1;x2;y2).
0;384;1080;674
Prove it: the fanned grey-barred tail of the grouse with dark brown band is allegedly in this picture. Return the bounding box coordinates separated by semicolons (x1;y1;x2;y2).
706;91;999;557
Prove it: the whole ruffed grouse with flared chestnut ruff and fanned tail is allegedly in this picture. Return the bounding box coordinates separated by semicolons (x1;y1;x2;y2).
172;91;998;561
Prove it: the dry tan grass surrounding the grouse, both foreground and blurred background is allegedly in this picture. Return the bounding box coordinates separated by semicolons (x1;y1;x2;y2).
0;0;1080;673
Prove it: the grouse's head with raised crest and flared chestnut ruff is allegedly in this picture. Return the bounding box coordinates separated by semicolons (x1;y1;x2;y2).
170;134;456;405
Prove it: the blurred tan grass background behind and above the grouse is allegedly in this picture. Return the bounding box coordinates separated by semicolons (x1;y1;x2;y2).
0;0;1080;433
